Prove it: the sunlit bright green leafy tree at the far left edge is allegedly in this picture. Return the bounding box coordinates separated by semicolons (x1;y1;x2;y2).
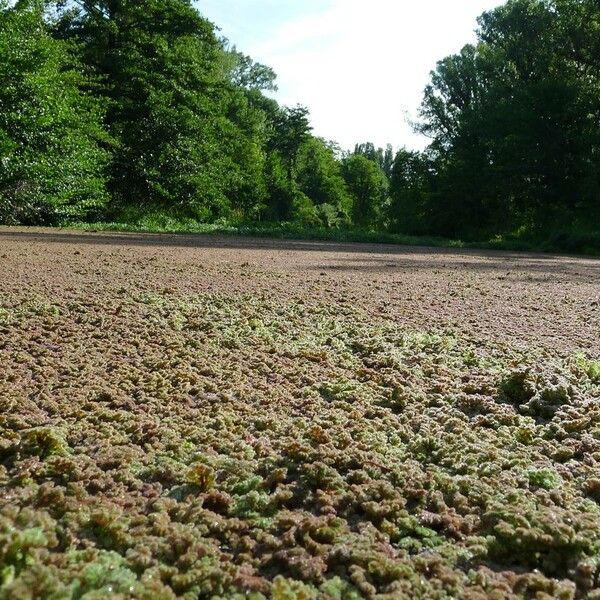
0;0;107;224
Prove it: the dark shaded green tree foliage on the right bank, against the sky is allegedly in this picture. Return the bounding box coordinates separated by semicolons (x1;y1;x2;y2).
416;0;600;237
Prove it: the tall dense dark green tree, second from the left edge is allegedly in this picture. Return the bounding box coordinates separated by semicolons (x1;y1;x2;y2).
49;0;264;220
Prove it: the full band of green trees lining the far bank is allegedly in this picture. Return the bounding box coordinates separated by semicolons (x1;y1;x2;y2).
0;0;600;244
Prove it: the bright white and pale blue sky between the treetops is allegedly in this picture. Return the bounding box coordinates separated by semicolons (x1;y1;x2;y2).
196;0;501;149
